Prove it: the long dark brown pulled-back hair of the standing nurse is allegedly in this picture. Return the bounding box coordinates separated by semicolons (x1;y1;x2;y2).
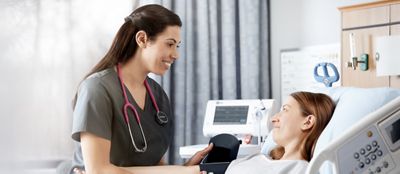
72;4;182;108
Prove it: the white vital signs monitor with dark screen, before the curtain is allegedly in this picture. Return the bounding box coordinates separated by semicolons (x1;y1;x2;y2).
203;99;278;137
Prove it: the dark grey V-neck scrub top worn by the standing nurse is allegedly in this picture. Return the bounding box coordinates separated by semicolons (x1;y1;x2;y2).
72;68;173;167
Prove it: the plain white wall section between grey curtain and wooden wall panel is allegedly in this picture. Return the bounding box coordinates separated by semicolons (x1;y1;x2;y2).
270;0;376;103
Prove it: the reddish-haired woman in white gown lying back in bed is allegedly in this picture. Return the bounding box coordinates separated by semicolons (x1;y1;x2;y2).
226;92;335;174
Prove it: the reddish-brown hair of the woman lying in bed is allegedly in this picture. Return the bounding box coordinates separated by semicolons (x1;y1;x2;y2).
269;92;335;161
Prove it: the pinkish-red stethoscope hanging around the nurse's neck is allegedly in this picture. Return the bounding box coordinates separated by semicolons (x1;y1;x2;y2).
117;64;168;152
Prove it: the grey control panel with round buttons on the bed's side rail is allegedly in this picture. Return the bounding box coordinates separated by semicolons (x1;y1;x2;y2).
337;111;400;174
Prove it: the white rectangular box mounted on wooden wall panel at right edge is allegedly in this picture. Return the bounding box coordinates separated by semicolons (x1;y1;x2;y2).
375;35;400;76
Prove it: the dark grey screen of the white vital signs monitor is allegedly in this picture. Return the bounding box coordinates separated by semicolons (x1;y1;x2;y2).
214;106;249;125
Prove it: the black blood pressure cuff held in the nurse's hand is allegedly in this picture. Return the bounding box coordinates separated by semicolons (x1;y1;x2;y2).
200;134;241;174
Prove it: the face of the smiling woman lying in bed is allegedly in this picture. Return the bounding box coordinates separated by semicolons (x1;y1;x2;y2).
271;97;305;147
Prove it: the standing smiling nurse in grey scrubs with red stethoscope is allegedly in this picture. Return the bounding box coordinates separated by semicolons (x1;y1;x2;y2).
71;5;212;174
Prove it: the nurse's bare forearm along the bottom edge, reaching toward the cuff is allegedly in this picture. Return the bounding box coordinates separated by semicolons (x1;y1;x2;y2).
124;165;200;174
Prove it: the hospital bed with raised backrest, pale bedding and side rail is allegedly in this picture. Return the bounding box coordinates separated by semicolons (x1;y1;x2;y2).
298;88;400;174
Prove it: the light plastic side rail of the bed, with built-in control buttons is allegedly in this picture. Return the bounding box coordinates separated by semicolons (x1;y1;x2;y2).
306;92;400;174
